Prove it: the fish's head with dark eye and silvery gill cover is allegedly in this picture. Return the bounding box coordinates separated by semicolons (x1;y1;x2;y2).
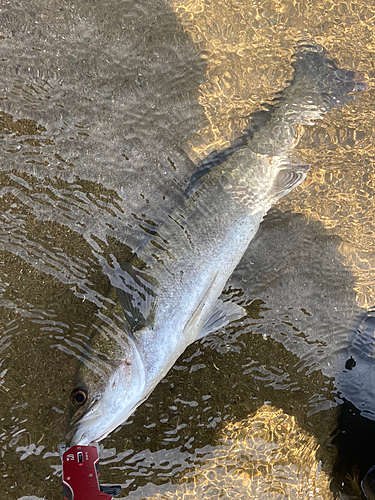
65;328;145;447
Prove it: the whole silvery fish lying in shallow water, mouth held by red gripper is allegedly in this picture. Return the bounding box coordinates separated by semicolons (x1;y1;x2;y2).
65;42;368;447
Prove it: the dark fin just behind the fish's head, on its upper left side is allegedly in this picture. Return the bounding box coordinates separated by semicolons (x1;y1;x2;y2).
116;259;156;331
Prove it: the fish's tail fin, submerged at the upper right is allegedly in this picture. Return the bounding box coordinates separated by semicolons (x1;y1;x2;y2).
280;42;369;123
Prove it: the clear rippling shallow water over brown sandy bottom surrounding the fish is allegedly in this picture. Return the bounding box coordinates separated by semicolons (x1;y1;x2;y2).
0;0;375;500
